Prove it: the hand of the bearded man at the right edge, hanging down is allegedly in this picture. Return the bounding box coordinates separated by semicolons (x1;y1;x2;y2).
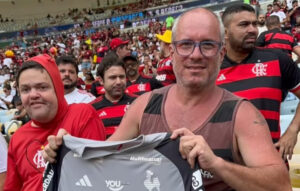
275;125;298;160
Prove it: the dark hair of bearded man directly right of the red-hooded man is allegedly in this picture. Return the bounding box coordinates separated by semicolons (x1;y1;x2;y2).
97;54;125;80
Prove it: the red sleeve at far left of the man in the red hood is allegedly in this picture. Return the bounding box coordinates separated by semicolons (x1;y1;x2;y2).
4;138;22;191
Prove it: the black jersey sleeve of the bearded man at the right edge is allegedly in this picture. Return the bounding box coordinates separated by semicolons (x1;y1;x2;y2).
277;52;300;92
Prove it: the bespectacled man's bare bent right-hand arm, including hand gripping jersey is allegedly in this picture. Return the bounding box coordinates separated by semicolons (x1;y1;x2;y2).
176;102;291;191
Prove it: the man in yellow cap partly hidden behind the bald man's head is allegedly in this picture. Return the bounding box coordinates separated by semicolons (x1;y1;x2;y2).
156;30;176;86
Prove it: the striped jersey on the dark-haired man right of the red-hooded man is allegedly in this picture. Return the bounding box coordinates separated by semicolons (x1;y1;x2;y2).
90;94;136;136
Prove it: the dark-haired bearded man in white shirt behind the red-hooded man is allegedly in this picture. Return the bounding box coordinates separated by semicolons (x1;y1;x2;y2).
56;56;96;104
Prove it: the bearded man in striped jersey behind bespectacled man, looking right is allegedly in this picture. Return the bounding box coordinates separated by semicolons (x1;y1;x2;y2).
216;4;300;159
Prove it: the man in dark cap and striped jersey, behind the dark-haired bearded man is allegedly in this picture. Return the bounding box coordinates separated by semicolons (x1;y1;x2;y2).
123;56;163;95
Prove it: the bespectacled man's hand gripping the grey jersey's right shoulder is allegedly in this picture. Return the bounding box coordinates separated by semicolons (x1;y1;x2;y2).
179;135;221;171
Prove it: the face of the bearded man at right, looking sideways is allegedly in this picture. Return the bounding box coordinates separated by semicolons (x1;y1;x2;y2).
225;11;258;52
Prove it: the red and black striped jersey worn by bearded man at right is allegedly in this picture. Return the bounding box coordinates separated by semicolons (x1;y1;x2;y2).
216;49;300;142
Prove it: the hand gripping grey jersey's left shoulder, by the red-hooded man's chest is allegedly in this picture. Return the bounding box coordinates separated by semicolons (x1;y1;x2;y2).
43;129;68;163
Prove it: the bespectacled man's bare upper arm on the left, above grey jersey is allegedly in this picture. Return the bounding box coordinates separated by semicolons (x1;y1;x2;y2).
108;92;150;141
